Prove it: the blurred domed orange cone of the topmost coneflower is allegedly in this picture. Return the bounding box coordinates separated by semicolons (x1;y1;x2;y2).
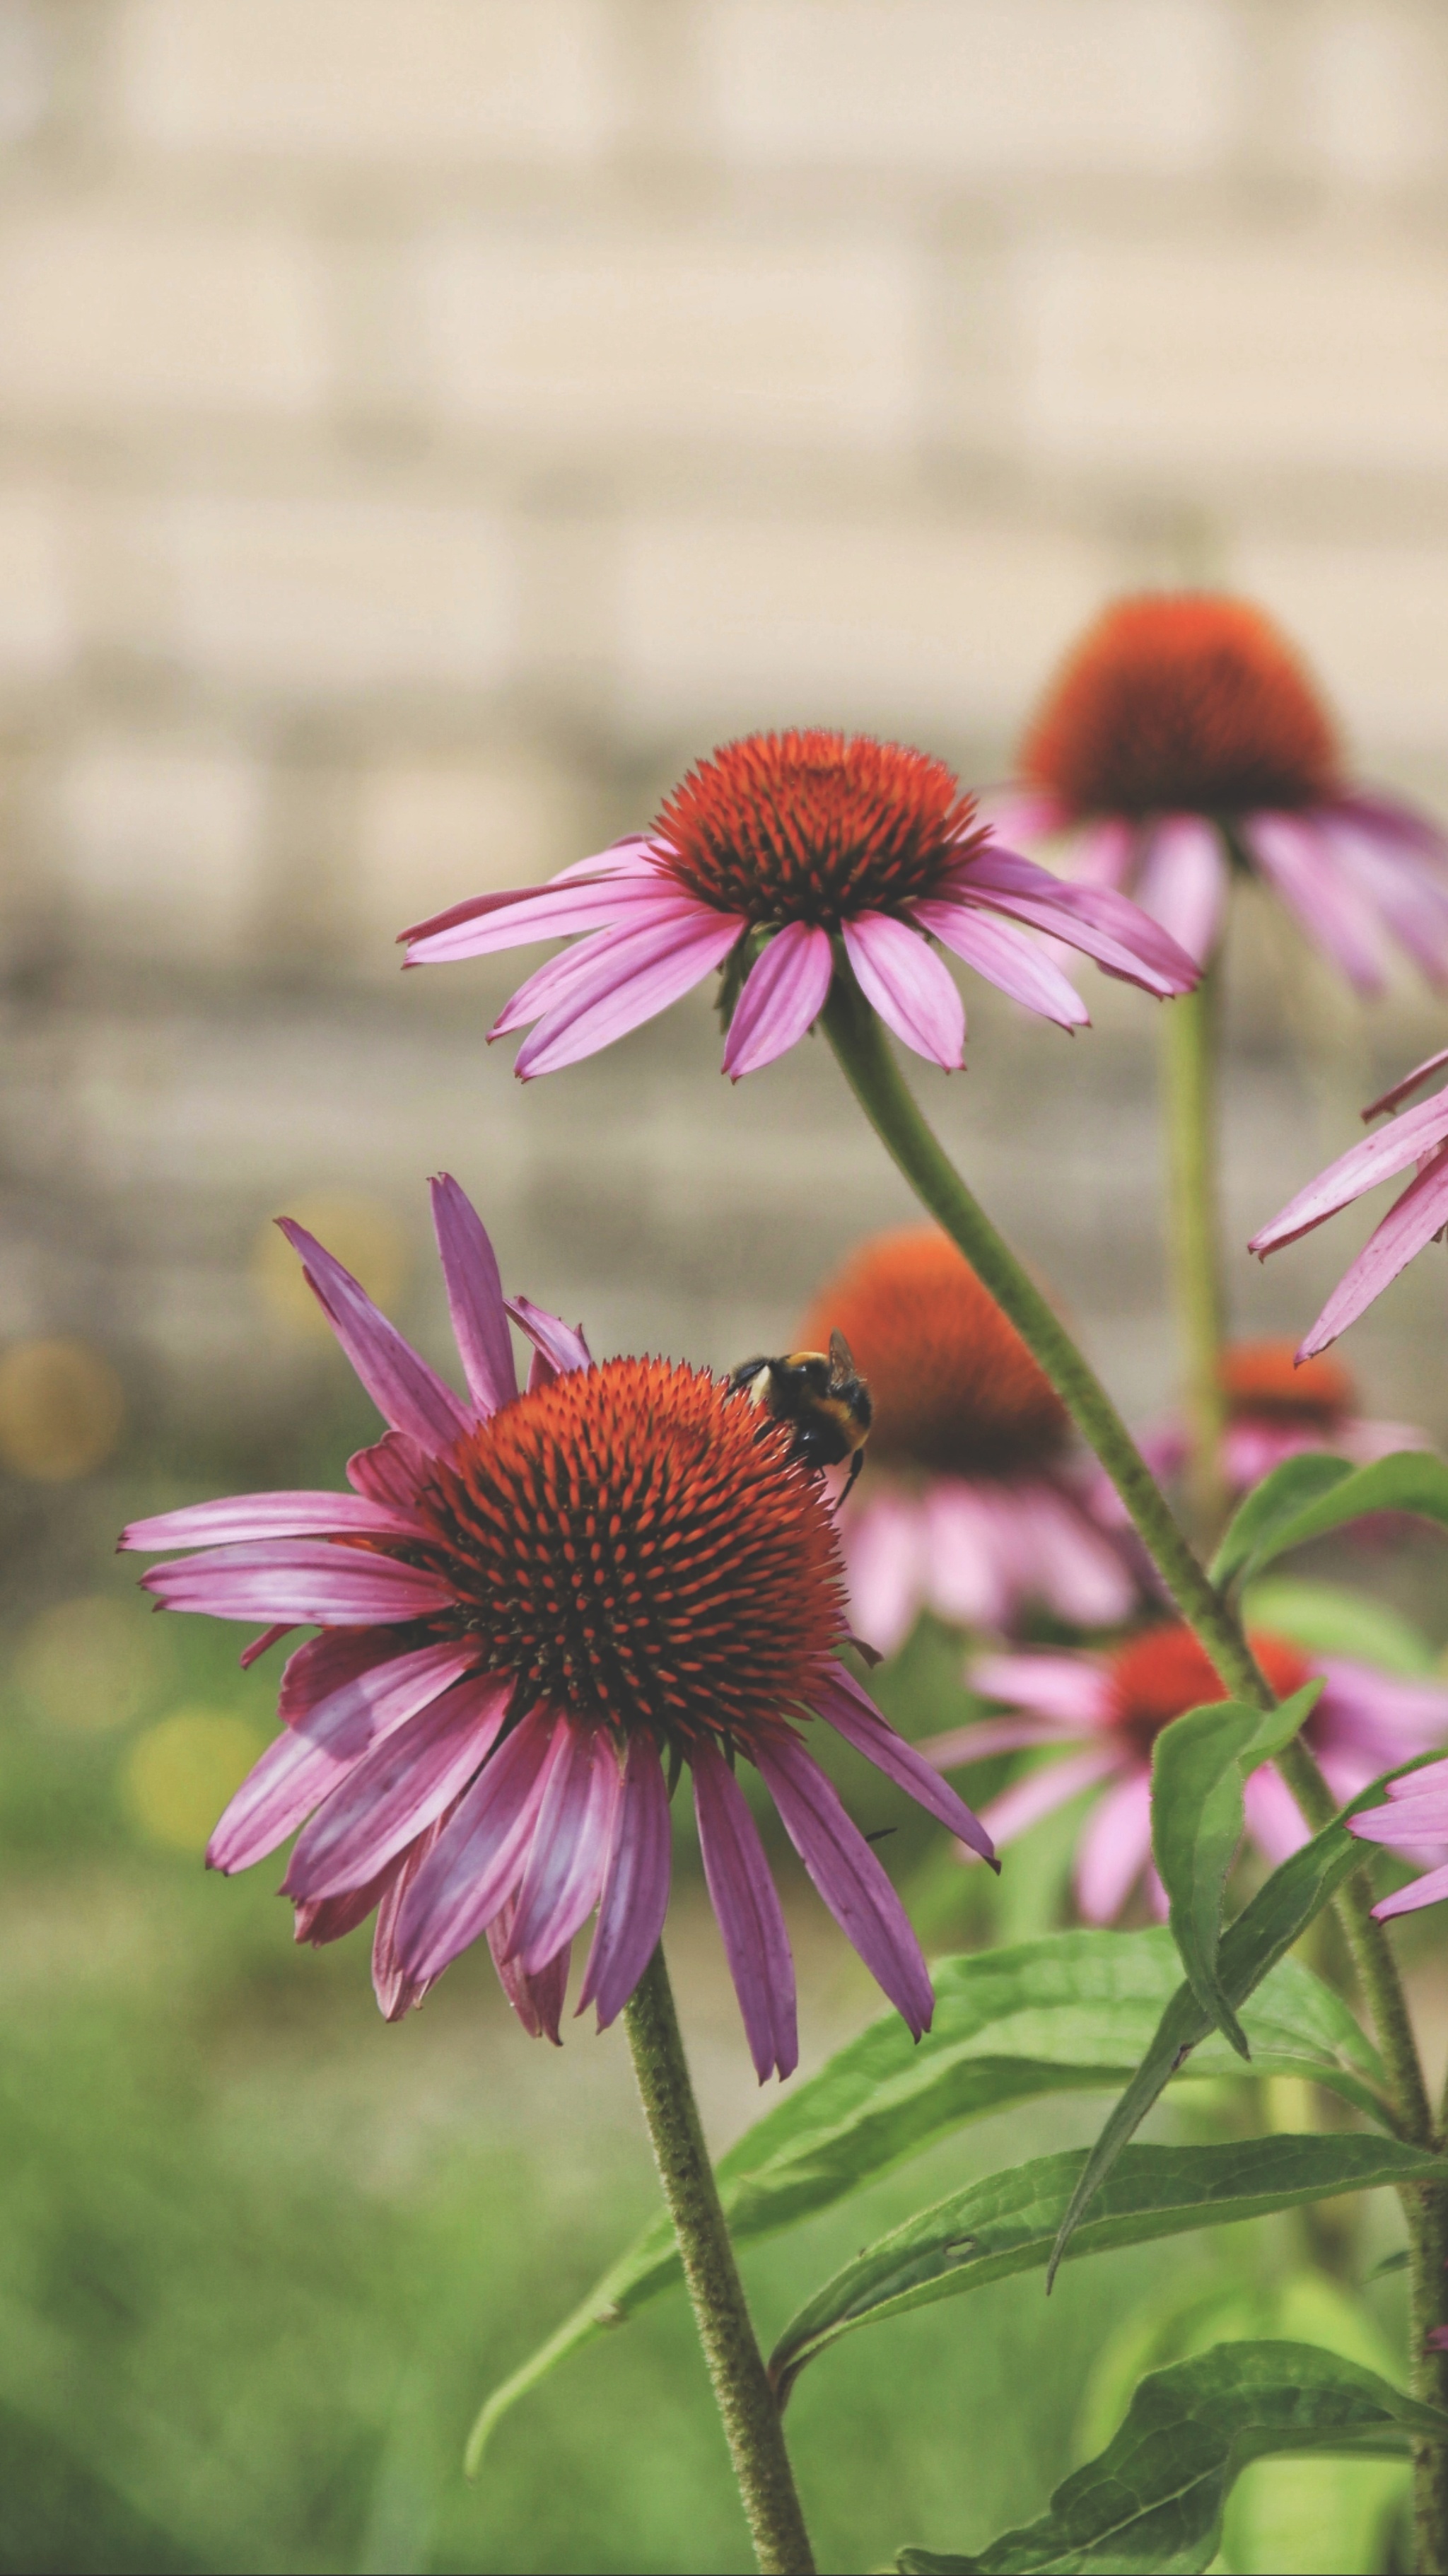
1020;593;1337;817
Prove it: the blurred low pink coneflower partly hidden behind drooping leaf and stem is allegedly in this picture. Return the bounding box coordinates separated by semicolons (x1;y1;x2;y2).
920;1623;1448;1924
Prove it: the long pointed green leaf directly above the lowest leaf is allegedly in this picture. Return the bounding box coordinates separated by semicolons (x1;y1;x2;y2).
771;2133;1448;2406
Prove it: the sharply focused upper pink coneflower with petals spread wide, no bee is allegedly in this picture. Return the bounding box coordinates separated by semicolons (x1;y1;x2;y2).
402;732;1196;1077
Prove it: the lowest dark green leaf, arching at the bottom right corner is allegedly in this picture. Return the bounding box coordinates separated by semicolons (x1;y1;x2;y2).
894;2344;1448;2576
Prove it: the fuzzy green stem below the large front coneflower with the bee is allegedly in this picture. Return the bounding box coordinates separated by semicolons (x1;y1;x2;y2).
624;1942;814;2576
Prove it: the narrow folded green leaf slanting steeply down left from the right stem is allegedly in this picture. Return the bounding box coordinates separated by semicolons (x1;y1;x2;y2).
1046;1783;1381;2287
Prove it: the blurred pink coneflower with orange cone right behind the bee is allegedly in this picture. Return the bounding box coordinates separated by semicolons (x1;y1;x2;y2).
801;1226;1136;1654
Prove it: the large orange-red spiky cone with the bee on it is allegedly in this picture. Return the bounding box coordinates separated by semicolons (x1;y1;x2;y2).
412;1360;845;1752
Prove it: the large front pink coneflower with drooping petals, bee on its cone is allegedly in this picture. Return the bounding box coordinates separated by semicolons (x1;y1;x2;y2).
121;1179;992;2082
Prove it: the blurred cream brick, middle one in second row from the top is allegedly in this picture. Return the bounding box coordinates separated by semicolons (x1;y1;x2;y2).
417;227;920;453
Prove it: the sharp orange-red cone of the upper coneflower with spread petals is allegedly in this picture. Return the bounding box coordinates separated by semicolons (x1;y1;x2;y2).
649;732;987;930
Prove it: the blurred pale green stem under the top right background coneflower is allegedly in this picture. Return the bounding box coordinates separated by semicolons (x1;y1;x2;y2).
1162;966;1227;1535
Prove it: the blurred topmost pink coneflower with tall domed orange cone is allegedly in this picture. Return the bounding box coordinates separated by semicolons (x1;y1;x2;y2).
1000;593;1448;992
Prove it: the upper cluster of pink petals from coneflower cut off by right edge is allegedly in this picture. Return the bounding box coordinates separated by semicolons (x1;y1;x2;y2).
1247;1046;1448;1360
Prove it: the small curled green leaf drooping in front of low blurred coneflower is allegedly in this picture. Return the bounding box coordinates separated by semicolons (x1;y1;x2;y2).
1152;1679;1324;2058
